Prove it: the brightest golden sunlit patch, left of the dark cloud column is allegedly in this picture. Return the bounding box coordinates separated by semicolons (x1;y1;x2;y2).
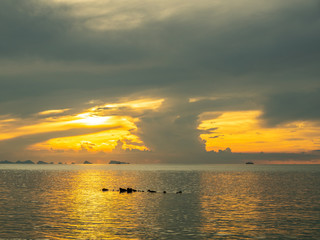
0;99;163;152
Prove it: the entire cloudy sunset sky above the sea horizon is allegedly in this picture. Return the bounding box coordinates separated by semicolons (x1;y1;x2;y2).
0;0;320;163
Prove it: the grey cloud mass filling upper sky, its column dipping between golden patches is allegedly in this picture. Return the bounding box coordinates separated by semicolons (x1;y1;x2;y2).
0;0;320;163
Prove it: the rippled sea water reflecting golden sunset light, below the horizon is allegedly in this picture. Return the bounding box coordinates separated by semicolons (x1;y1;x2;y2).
0;164;320;239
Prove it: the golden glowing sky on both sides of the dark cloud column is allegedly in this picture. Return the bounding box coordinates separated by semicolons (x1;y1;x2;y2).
0;99;320;158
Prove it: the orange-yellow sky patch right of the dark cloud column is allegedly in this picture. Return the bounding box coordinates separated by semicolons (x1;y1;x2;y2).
199;111;320;153
